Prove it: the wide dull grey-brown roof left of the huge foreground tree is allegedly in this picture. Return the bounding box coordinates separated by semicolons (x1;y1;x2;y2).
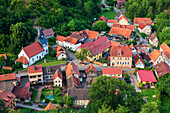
67;89;88;100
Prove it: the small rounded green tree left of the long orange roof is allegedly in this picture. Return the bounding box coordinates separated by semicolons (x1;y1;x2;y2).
94;20;107;31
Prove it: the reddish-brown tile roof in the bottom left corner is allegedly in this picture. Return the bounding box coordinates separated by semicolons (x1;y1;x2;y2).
0;90;16;107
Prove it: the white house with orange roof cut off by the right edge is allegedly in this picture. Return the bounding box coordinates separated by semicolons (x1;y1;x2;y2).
162;47;170;66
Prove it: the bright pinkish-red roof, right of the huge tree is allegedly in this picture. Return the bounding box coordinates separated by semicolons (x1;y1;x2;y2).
137;70;157;82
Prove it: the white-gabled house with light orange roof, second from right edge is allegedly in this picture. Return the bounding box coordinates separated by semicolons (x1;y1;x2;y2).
150;49;164;65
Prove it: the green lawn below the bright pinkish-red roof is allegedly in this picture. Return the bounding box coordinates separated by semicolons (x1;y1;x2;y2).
141;89;157;102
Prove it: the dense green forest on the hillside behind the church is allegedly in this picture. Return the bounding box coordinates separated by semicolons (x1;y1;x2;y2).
0;0;101;54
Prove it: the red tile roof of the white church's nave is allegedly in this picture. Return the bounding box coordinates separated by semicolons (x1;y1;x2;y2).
23;42;44;58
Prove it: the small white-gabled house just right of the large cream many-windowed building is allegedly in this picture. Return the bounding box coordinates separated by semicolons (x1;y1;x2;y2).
134;53;145;68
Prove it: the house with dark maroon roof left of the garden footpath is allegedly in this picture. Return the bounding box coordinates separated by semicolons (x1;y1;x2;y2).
12;86;32;102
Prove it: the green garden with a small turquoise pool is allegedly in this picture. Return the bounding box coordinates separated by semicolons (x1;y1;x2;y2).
40;87;62;105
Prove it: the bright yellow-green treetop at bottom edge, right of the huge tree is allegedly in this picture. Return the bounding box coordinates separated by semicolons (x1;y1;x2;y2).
140;102;159;113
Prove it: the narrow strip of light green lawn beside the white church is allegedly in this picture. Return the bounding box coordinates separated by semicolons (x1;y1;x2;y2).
36;60;66;67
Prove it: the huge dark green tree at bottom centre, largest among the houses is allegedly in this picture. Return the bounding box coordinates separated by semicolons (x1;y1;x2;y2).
87;76;144;113
